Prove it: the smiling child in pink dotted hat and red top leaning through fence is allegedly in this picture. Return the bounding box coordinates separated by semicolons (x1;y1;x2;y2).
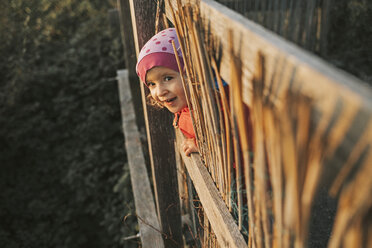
136;28;198;156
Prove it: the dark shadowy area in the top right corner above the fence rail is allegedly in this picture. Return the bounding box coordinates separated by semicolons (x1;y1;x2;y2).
324;0;372;86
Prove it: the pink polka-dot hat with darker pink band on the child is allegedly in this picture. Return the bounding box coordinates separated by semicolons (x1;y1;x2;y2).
136;28;183;84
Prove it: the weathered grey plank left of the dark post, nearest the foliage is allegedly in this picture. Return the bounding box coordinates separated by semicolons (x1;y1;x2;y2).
117;70;164;248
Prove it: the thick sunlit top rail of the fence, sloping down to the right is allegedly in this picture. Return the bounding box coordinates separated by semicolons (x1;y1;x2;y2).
166;0;372;110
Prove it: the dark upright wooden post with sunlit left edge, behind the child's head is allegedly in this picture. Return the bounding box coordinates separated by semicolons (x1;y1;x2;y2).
129;0;183;247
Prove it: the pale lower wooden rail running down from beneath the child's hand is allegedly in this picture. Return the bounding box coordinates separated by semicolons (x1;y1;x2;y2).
176;130;247;247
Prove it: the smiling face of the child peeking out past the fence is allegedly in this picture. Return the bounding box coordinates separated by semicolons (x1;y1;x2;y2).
146;66;187;113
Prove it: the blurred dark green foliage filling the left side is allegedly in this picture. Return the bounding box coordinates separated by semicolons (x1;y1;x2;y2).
0;0;137;248
